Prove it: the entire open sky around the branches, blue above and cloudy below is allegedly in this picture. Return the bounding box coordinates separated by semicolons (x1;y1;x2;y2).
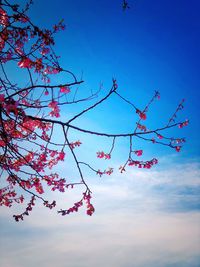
0;0;200;267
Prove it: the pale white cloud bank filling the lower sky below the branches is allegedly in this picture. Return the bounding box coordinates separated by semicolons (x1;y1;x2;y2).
0;163;200;267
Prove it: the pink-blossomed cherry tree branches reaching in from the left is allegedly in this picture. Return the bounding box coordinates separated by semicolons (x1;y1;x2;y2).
0;0;189;222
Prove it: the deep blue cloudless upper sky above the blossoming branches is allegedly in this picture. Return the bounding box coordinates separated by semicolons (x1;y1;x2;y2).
26;0;200;156
